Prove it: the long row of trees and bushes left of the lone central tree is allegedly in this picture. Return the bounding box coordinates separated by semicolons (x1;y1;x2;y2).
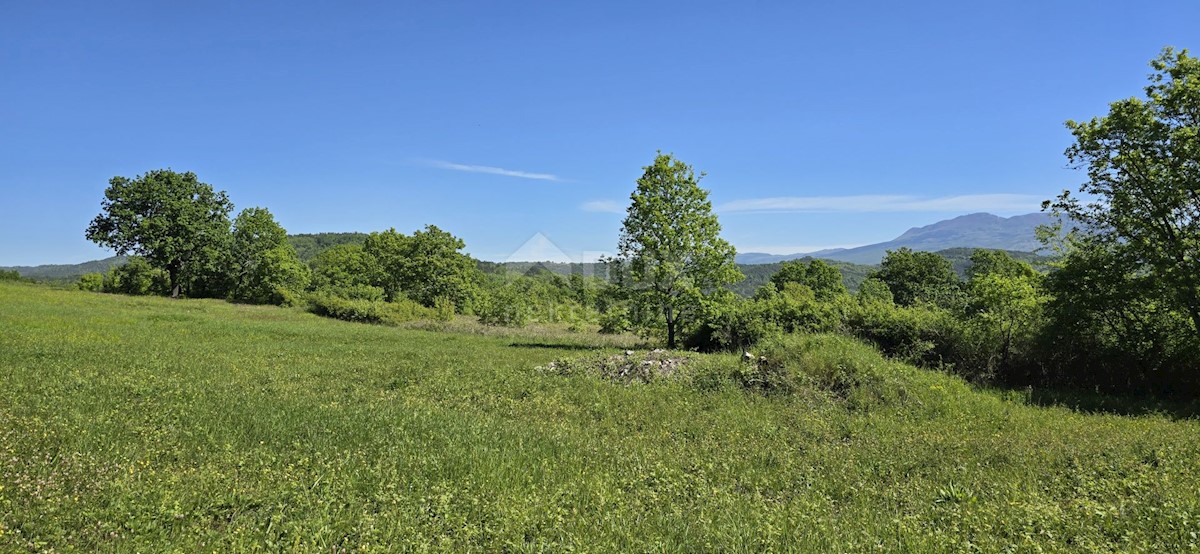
77;169;611;330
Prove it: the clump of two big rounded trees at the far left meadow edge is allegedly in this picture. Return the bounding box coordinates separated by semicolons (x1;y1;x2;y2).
84;169;308;303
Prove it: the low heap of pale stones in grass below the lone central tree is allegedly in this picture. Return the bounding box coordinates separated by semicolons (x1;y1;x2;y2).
539;349;695;385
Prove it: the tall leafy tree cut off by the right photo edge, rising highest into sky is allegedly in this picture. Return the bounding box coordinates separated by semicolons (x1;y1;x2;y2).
1043;48;1200;338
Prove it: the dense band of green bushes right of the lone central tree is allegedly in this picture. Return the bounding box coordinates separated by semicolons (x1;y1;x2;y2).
685;249;1200;397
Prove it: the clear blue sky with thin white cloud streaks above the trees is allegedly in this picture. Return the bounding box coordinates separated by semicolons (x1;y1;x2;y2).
0;0;1200;265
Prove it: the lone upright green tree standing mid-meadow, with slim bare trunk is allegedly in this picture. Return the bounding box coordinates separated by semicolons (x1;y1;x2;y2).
611;152;743;348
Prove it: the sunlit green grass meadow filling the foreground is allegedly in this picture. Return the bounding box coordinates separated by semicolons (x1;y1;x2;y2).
0;283;1200;552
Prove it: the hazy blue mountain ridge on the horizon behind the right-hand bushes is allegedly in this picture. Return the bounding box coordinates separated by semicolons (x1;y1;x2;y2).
737;213;1056;264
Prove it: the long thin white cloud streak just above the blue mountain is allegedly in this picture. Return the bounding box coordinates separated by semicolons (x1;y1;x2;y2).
718;194;1044;213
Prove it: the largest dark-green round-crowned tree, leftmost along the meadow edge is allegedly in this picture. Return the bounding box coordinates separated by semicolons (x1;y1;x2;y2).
86;169;233;297
